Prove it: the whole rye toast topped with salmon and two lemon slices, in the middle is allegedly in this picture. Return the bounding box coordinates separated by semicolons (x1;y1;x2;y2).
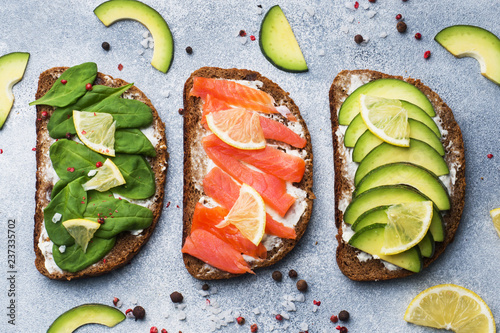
182;67;314;280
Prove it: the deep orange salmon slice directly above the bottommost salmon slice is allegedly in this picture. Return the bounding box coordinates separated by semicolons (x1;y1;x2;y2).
191;203;267;259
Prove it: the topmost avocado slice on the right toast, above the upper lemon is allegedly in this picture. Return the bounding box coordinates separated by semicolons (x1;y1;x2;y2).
338;79;436;126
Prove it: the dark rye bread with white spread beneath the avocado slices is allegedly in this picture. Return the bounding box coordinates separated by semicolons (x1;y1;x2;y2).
330;70;465;281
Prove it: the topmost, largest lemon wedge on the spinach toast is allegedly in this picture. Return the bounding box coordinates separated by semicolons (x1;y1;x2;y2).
73;110;116;156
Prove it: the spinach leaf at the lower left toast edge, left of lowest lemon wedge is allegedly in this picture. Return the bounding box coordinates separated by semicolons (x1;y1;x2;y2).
43;177;88;245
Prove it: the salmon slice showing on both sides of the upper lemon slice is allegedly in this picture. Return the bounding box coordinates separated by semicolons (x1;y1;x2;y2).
201;94;307;148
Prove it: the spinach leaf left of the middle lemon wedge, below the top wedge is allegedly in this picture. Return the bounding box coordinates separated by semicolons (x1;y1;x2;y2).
49;140;106;182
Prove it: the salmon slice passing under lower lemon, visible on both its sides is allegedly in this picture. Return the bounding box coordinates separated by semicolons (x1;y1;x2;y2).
203;167;297;239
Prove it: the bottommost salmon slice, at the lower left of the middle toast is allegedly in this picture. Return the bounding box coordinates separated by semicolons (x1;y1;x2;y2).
182;229;254;274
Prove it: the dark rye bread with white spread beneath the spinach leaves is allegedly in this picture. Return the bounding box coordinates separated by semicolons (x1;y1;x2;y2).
34;67;168;280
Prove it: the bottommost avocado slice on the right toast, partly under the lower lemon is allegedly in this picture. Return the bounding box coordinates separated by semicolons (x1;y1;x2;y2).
349;223;423;273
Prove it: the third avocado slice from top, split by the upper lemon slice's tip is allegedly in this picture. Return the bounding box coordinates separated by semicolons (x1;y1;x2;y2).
352;119;444;163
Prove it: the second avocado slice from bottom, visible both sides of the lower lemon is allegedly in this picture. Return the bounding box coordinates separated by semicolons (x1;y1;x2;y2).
351;206;444;242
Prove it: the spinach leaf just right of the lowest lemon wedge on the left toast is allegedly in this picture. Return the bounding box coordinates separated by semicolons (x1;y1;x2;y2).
83;191;153;238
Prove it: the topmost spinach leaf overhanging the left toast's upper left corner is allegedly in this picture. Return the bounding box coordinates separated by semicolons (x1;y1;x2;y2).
30;62;97;107
